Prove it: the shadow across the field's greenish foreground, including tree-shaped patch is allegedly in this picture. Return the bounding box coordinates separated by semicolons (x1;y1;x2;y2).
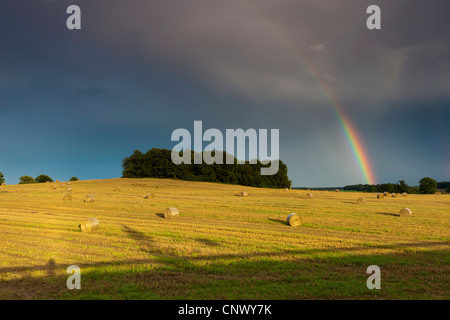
0;235;450;299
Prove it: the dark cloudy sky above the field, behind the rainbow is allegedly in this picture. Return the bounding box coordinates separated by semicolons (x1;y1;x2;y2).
0;0;450;187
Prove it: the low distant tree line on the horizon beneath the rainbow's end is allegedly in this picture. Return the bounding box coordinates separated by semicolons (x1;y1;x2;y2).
344;177;444;194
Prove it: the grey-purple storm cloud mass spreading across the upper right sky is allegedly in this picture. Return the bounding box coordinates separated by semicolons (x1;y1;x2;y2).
73;0;450;107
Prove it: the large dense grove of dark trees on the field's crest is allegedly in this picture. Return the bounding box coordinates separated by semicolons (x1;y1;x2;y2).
122;148;292;188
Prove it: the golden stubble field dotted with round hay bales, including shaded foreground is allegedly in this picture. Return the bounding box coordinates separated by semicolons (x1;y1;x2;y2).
0;179;450;299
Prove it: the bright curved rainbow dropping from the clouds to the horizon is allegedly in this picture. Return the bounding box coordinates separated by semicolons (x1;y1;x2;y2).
251;5;377;184
